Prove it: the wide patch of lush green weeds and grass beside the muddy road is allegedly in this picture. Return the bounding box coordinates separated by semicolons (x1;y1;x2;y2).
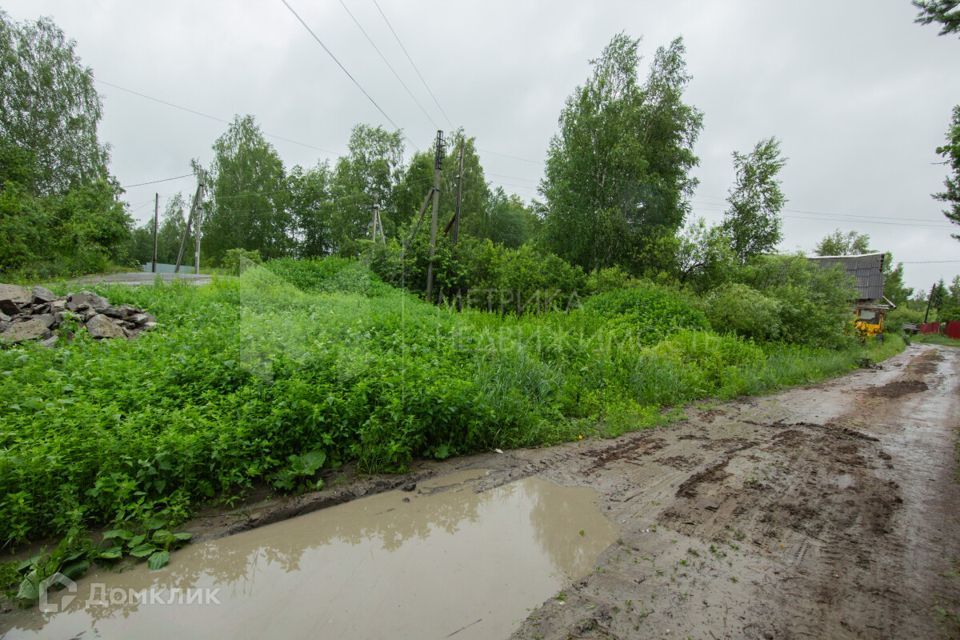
0;264;903;545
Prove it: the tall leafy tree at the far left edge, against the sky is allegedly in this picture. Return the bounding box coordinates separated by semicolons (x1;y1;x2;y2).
0;11;108;195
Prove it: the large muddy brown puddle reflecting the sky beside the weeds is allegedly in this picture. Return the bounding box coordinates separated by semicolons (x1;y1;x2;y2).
0;472;617;640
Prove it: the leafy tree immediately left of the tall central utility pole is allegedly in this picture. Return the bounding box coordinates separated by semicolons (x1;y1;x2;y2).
331;124;403;255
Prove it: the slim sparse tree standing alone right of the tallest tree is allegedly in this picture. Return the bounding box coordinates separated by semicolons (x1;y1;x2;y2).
723;138;786;263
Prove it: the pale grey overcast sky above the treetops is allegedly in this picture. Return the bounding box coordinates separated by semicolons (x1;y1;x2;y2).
2;0;960;288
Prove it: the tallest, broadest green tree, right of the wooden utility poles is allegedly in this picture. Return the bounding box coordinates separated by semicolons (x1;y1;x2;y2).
541;33;702;273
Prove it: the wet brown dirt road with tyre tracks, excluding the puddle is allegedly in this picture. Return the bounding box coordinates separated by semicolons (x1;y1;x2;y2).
109;345;960;640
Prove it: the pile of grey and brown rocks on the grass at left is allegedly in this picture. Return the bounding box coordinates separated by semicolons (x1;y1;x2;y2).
0;284;157;347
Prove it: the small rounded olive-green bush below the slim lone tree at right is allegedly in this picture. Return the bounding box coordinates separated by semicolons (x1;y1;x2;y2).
704;283;783;340
